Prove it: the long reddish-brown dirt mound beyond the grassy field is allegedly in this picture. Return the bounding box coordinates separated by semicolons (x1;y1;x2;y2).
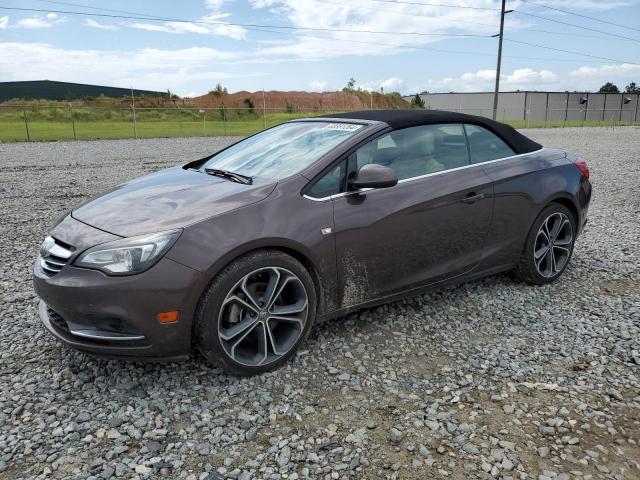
189;91;409;111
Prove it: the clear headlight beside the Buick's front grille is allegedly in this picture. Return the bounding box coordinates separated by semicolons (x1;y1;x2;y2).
74;230;182;275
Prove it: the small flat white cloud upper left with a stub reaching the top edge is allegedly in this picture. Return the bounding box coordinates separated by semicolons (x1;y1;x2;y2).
129;0;247;40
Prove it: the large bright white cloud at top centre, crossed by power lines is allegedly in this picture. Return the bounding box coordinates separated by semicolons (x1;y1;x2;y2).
245;0;525;59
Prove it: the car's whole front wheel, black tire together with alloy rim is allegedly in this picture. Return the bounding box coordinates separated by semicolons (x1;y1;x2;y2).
195;250;317;376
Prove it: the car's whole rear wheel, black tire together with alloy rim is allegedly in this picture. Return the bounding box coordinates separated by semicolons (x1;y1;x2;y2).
514;203;576;285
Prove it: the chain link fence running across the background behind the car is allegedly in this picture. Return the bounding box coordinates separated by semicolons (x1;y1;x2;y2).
0;100;640;142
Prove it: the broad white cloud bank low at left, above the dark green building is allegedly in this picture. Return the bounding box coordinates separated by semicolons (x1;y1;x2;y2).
0;42;262;94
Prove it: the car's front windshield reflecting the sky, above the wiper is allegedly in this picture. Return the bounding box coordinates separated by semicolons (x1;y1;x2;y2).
202;122;363;180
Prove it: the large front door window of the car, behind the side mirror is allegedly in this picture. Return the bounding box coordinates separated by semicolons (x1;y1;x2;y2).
356;124;469;180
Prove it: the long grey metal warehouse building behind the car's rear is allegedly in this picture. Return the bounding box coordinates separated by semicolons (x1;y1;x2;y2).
405;91;640;123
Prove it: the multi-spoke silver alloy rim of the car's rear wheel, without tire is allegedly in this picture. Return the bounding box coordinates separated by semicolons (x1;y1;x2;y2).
533;212;573;278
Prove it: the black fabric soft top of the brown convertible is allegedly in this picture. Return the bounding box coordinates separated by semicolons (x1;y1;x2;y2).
323;109;542;154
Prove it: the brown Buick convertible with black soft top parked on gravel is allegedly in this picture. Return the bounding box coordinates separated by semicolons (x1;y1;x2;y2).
34;110;591;375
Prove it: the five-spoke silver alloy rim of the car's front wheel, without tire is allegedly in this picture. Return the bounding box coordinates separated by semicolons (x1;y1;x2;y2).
218;267;308;367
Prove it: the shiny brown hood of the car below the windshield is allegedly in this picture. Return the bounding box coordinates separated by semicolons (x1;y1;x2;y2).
71;167;276;237
